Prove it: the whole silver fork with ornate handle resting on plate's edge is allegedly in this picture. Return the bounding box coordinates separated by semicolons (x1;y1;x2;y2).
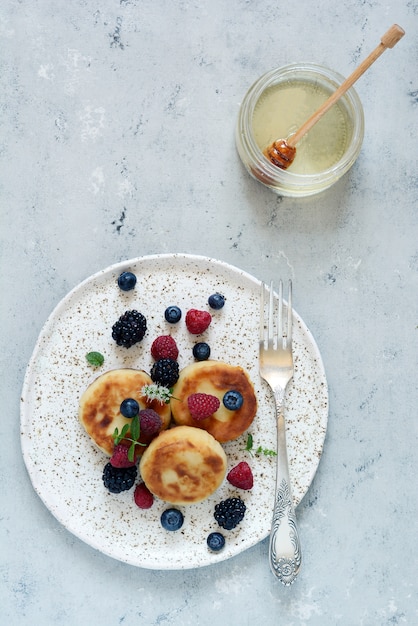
260;280;302;586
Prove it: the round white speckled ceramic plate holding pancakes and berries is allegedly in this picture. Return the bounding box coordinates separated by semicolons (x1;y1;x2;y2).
21;254;328;569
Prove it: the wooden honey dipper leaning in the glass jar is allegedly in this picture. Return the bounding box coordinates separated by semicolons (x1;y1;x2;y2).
263;24;405;170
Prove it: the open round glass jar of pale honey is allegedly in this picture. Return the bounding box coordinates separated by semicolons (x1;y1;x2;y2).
236;63;364;197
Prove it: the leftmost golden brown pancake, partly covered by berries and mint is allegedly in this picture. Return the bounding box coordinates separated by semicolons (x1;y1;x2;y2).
79;368;171;456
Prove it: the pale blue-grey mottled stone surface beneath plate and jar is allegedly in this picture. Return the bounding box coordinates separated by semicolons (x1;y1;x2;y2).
0;0;418;626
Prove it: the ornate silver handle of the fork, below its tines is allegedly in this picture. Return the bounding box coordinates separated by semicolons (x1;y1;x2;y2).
269;390;302;586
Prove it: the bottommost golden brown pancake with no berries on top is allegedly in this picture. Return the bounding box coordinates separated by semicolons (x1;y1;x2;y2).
139;426;227;504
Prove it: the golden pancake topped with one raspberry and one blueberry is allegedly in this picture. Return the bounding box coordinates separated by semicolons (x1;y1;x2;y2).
171;360;257;443
